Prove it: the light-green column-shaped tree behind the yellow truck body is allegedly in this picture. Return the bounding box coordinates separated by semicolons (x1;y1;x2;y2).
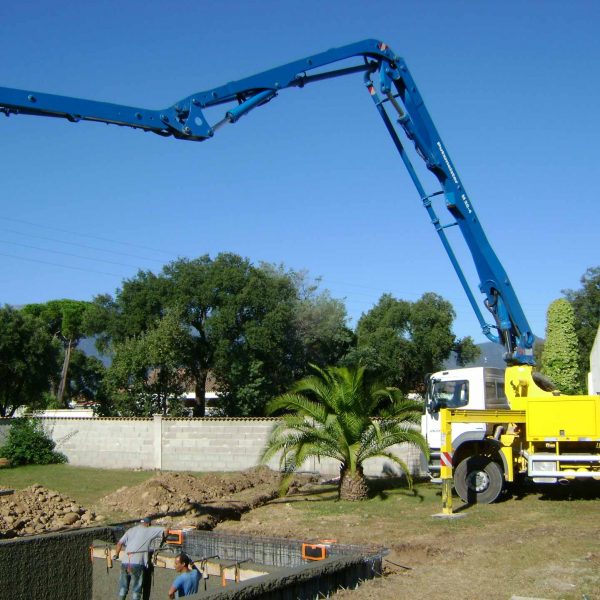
540;298;581;394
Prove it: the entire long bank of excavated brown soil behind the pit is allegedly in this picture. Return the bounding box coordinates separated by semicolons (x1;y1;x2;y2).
0;467;310;538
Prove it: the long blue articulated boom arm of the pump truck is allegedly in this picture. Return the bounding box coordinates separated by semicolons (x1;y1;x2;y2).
0;40;534;364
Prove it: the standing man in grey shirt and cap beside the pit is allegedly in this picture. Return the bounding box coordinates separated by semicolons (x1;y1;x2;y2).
115;517;167;600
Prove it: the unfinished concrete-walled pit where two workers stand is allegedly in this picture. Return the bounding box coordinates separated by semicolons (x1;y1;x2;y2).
0;524;386;600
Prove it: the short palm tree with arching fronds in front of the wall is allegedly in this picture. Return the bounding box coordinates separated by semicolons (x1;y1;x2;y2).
262;366;429;500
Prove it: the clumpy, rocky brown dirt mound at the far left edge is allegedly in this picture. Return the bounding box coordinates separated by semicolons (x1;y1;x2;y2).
0;485;96;538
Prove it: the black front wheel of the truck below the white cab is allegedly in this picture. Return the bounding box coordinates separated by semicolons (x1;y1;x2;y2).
454;456;504;504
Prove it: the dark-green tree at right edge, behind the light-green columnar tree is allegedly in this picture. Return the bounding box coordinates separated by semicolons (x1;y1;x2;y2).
562;267;600;388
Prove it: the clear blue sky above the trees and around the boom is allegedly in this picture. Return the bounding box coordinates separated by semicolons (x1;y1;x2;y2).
0;0;600;341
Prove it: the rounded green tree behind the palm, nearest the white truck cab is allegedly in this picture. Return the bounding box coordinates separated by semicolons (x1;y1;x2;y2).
345;293;460;392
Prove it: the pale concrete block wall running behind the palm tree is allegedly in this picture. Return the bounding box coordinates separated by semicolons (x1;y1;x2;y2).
0;416;421;477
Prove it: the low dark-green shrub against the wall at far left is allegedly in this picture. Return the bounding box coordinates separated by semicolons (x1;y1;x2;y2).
0;418;67;467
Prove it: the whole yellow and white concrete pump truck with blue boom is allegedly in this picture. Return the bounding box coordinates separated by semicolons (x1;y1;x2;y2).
0;40;600;503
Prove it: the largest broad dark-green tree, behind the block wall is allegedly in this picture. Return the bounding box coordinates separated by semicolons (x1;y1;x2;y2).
96;254;301;416
